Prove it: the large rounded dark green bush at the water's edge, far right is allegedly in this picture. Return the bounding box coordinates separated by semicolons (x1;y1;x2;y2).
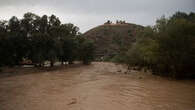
156;18;195;77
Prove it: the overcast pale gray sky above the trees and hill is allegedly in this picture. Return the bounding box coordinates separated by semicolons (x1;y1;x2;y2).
0;0;195;32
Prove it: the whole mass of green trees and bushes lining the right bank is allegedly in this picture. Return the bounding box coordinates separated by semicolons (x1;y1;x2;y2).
115;12;195;78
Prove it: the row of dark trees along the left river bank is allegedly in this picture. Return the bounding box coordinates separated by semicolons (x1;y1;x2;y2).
0;13;94;66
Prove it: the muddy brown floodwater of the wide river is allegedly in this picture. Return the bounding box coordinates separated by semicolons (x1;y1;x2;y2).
0;62;195;110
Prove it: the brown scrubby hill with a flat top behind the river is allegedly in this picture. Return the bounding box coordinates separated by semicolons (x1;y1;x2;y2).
84;22;144;57
